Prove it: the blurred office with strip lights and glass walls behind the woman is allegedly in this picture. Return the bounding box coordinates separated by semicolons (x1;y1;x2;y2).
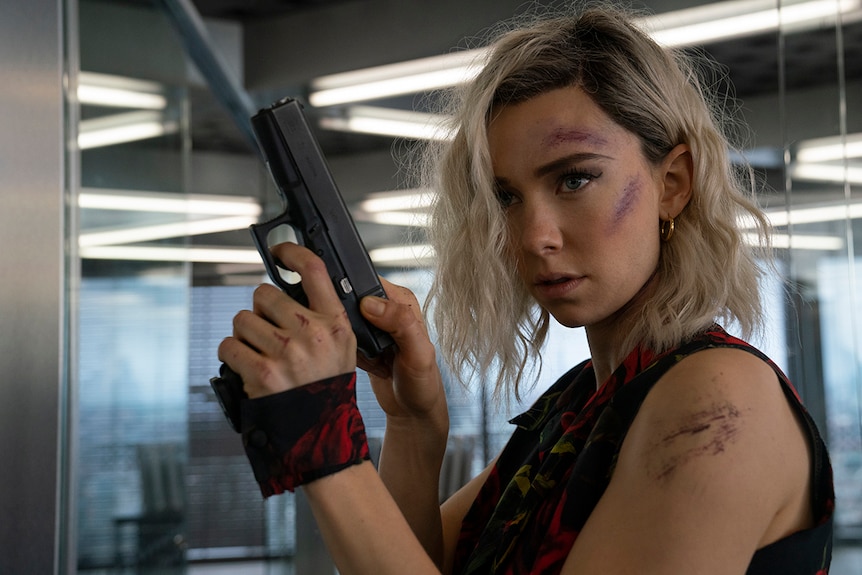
5;0;862;575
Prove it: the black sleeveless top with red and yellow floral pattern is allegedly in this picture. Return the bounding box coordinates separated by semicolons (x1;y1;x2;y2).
452;326;834;575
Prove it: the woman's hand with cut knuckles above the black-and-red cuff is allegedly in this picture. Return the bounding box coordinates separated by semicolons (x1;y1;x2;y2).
223;243;356;398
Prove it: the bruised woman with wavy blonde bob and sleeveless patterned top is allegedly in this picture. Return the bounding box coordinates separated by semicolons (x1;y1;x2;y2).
219;8;833;575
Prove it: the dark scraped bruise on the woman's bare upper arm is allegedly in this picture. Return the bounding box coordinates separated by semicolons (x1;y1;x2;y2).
650;403;742;481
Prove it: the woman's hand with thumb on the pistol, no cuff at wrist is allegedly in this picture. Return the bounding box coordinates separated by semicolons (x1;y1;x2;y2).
357;279;448;429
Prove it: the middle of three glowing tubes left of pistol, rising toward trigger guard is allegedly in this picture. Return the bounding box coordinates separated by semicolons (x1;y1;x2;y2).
78;216;257;247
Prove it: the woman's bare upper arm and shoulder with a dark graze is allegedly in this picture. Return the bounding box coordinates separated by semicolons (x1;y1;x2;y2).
563;349;812;575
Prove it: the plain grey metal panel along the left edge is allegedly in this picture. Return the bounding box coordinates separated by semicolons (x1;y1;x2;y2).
0;0;64;573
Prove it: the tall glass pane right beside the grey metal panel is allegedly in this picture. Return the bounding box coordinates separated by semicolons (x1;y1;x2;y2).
74;0;192;573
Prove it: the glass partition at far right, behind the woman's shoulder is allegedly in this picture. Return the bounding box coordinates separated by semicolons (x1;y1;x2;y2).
771;2;862;560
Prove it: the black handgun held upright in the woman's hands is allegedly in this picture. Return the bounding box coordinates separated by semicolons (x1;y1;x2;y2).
210;98;394;432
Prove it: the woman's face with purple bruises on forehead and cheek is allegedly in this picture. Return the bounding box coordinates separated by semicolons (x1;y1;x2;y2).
488;83;667;327
